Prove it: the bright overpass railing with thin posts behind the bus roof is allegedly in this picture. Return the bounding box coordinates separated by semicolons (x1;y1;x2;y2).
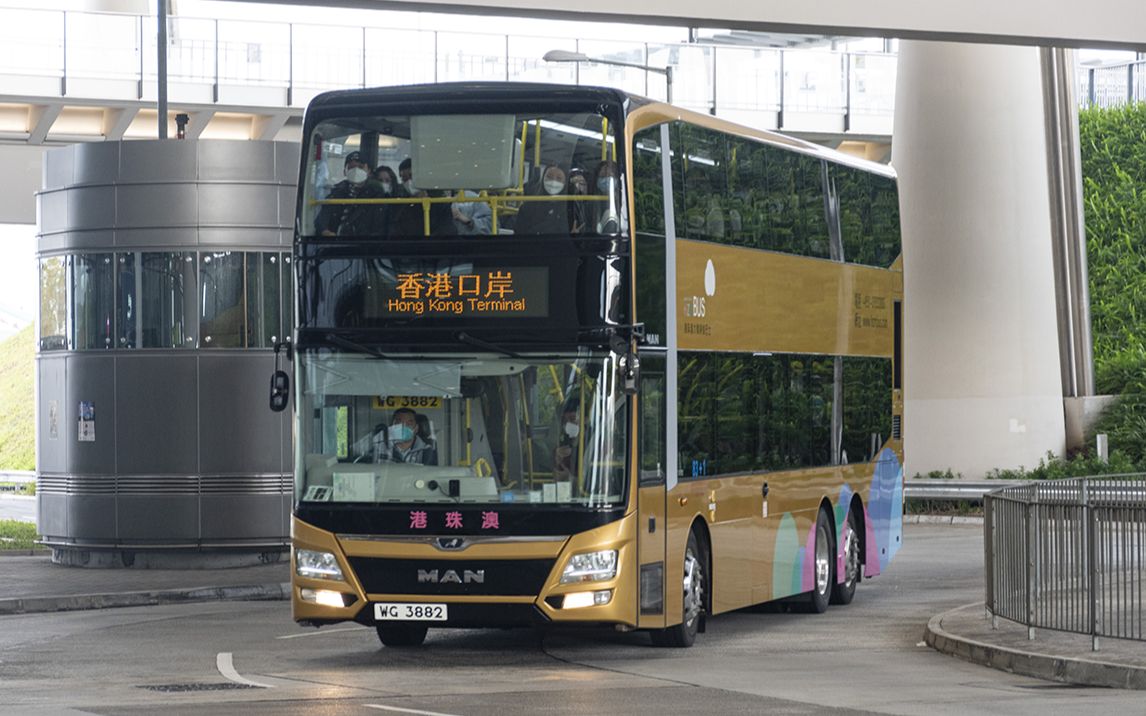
0;8;896;135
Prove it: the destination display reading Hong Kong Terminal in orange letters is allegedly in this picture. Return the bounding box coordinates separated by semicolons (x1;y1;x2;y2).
366;265;549;318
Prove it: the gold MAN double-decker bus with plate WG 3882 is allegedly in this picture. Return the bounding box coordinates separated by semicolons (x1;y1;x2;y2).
279;82;903;646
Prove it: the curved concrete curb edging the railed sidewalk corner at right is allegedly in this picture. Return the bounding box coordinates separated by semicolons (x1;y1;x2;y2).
924;603;1146;690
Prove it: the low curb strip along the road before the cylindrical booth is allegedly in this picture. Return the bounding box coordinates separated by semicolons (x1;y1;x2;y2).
0;582;290;616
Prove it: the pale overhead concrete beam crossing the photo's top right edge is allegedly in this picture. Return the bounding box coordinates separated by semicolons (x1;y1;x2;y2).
245;0;1146;50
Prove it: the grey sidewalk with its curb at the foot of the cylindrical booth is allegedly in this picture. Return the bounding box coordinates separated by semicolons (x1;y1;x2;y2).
0;554;290;616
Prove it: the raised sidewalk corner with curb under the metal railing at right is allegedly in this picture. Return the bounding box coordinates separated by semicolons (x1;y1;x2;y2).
925;603;1146;690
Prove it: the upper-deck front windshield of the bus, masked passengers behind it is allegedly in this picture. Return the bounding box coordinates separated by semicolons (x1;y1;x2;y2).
299;112;626;238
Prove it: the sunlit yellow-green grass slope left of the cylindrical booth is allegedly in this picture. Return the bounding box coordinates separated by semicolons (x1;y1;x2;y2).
0;325;36;470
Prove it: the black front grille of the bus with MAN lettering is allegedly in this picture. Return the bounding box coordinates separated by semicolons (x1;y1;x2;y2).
350;557;555;597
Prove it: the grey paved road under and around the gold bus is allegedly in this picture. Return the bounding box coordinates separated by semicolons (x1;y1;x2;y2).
0;525;1146;716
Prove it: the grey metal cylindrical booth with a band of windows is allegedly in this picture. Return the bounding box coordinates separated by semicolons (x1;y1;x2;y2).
36;140;299;567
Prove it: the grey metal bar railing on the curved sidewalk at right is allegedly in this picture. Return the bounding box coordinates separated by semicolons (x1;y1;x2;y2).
983;475;1146;651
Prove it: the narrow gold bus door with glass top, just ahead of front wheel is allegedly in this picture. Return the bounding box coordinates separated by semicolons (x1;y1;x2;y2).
636;352;668;629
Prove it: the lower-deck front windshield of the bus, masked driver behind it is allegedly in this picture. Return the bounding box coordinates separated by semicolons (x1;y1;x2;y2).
297;349;627;508
